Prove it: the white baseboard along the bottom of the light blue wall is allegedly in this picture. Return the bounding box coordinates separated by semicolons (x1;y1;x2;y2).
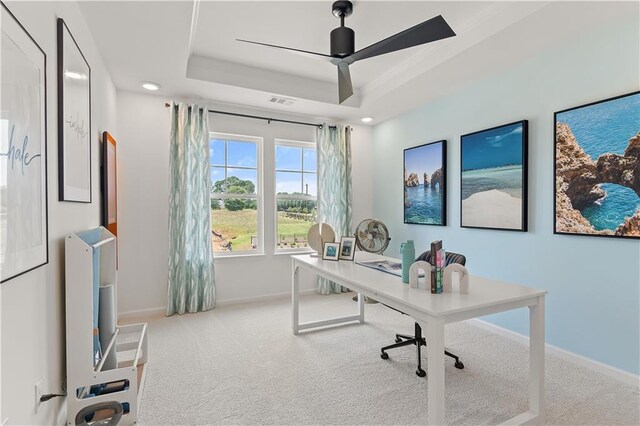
467;318;640;387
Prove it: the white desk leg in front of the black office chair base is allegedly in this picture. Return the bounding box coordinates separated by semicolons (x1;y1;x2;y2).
421;318;444;425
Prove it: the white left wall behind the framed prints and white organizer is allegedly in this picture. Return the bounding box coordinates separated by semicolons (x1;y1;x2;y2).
0;1;117;425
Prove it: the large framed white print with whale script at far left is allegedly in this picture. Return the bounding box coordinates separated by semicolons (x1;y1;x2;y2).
0;2;49;283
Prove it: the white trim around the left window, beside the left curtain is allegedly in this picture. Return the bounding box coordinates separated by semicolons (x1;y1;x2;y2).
209;132;265;258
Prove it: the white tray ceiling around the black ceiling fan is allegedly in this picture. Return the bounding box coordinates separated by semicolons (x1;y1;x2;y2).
80;0;639;124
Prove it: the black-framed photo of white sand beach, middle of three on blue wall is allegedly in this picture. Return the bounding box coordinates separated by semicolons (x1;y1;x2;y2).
460;120;528;232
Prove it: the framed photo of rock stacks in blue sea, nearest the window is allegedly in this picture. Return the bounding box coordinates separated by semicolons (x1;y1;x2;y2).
403;140;447;226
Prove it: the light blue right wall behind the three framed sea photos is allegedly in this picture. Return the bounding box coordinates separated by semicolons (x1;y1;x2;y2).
374;16;640;374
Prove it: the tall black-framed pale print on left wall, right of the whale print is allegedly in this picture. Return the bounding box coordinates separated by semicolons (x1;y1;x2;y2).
58;18;91;203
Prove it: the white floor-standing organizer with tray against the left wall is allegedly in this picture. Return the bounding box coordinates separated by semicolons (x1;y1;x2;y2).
65;227;147;425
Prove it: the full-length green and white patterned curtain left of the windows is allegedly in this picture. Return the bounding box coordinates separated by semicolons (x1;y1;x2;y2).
167;104;215;316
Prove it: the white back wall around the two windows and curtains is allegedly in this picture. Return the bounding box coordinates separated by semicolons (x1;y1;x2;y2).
118;91;373;312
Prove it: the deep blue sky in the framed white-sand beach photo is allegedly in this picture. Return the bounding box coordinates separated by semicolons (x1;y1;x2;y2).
461;123;523;171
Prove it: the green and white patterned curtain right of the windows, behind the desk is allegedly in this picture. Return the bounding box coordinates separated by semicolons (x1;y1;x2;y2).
316;124;352;294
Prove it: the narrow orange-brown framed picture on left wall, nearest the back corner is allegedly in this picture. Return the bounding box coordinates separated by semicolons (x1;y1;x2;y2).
102;132;118;236
